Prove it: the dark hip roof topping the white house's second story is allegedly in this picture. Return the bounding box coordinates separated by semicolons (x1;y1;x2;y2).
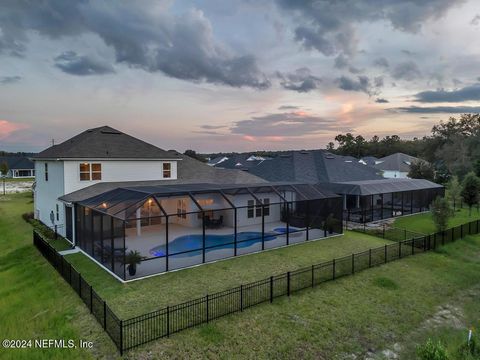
34;126;178;160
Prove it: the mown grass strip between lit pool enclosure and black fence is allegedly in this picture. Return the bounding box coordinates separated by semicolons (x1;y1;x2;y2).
67;231;390;317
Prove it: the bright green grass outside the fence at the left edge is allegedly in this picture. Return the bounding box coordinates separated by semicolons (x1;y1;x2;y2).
0;193;115;360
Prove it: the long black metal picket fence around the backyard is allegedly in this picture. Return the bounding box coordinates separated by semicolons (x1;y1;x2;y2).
34;220;480;353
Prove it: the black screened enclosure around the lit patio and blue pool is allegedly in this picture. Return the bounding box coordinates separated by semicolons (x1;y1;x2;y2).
75;184;342;280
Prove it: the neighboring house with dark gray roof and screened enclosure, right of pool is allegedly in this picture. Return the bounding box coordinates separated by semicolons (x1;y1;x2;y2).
244;150;445;223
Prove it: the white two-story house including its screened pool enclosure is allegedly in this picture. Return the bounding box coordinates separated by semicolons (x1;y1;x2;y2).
34;126;343;281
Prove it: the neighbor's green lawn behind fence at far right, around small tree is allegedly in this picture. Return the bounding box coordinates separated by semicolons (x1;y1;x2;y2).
393;207;480;234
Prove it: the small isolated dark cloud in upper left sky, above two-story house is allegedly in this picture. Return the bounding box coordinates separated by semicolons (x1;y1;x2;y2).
54;51;115;75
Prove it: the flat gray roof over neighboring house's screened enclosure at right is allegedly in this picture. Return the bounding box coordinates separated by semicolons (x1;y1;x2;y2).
321;179;443;195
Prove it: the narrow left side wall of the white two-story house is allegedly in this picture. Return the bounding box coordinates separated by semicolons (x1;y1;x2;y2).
34;161;65;236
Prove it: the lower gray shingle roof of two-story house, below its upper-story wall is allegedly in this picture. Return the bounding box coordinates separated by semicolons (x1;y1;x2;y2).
59;151;267;202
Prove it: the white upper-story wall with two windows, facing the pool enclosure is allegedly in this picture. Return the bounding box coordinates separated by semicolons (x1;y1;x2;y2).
64;160;177;194
